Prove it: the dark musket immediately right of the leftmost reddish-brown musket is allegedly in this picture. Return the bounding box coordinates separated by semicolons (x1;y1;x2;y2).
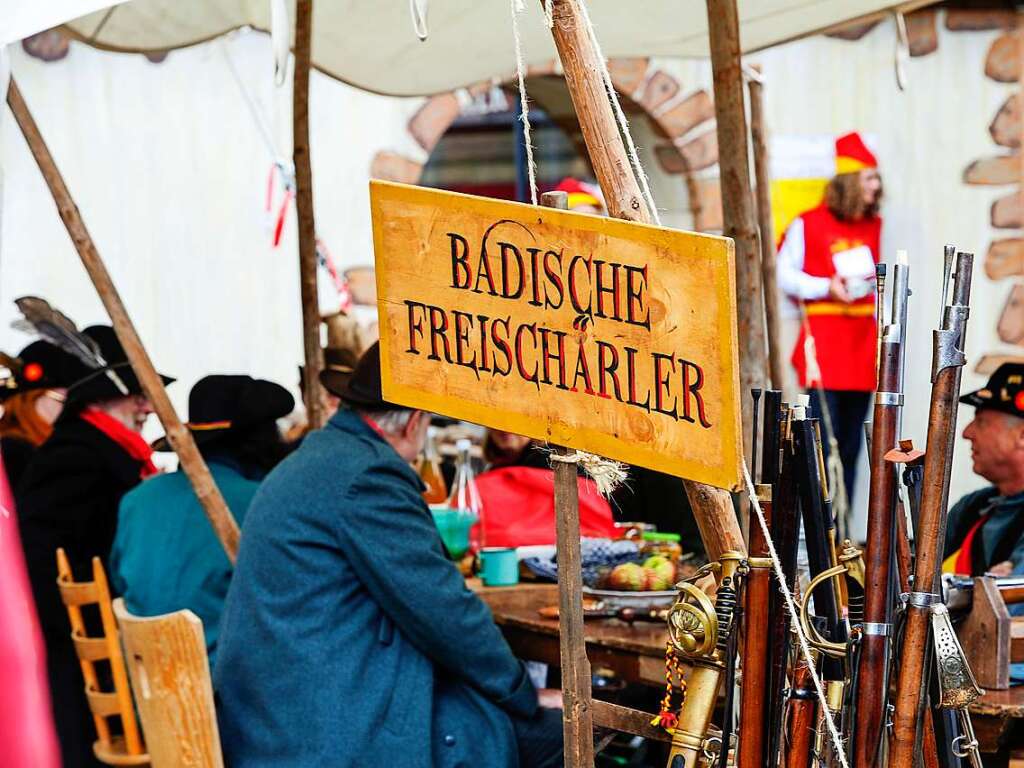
764;403;808;766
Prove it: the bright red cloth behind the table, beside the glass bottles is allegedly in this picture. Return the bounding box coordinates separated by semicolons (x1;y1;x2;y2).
476;467;615;547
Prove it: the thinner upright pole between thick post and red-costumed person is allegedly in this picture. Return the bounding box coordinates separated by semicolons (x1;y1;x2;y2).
746;67;784;389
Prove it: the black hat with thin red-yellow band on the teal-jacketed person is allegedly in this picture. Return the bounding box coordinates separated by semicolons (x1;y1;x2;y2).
153;374;295;451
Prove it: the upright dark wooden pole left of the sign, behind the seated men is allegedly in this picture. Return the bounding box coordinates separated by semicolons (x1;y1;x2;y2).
292;0;325;429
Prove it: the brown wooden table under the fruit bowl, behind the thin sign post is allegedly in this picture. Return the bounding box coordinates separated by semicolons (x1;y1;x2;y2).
468;580;669;688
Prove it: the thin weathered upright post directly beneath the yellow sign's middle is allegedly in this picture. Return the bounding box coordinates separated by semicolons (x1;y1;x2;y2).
541;191;594;768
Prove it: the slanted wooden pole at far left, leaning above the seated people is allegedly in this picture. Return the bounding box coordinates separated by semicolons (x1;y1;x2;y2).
7;78;239;563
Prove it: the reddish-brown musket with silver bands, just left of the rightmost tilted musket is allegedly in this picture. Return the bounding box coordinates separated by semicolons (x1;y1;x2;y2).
853;252;909;768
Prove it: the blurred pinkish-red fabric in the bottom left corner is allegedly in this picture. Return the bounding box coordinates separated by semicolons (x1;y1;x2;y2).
0;448;60;768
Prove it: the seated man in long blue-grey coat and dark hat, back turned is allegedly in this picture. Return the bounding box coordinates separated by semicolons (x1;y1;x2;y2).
214;344;561;768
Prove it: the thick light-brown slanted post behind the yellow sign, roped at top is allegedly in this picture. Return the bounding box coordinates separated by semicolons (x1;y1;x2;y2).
551;0;745;559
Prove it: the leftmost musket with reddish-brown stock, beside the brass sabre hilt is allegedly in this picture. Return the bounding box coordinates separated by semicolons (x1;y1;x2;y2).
736;391;781;768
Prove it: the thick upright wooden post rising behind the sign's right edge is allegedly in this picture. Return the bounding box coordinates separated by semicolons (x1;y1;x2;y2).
707;0;765;454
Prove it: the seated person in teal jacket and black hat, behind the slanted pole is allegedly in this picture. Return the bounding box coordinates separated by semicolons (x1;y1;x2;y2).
110;376;295;666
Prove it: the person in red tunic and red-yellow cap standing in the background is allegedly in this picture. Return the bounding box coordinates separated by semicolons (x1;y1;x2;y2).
778;133;882;505
